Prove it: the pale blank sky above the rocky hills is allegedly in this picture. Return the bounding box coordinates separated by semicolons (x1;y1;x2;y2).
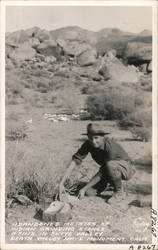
6;6;152;33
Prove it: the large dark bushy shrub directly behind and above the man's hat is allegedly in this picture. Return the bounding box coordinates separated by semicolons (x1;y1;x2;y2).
87;88;136;120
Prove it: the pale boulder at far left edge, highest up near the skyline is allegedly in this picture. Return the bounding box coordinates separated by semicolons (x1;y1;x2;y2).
6;30;29;46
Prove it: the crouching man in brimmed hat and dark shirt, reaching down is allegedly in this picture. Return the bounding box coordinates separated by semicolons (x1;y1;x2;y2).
60;123;135;204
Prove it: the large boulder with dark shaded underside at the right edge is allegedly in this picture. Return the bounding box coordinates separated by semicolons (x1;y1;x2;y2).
124;42;152;63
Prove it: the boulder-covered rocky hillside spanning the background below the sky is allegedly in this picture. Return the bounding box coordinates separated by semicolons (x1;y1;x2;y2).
6;26;152;75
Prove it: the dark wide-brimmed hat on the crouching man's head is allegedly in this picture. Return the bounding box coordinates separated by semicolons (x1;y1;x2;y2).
82;123;110;136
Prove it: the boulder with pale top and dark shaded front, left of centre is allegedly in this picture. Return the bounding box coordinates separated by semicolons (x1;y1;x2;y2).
37;40;62;58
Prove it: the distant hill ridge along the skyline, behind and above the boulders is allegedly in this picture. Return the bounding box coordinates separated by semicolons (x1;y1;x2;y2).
6;26;152;53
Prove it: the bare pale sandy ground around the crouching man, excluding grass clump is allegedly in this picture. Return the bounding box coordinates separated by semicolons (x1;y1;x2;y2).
6;109;151;244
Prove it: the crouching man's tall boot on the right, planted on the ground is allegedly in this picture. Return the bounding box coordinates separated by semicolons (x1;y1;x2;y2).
108;176;125;205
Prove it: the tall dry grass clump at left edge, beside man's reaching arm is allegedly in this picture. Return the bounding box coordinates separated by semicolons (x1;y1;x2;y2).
6;141;62;202
